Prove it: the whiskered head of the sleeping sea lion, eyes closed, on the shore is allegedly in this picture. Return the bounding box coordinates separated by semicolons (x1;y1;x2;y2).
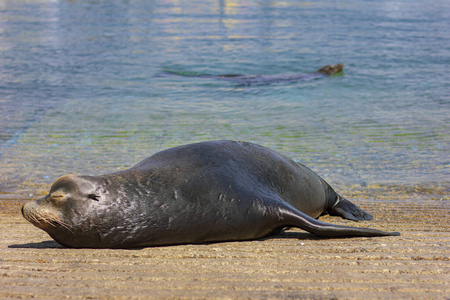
22;175;110;247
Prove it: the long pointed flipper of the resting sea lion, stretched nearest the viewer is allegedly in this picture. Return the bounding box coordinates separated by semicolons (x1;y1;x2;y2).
279;204;400;237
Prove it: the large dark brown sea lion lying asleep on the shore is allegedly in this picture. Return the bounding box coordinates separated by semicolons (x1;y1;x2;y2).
22;141;399;248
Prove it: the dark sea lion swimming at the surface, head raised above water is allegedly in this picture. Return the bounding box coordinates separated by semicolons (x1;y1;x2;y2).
161;64;344;85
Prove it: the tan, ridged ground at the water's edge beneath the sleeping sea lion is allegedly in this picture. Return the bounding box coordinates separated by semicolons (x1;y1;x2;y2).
0;188;450;299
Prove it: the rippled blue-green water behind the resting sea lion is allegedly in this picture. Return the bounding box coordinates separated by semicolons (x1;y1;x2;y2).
0;0;450;198
